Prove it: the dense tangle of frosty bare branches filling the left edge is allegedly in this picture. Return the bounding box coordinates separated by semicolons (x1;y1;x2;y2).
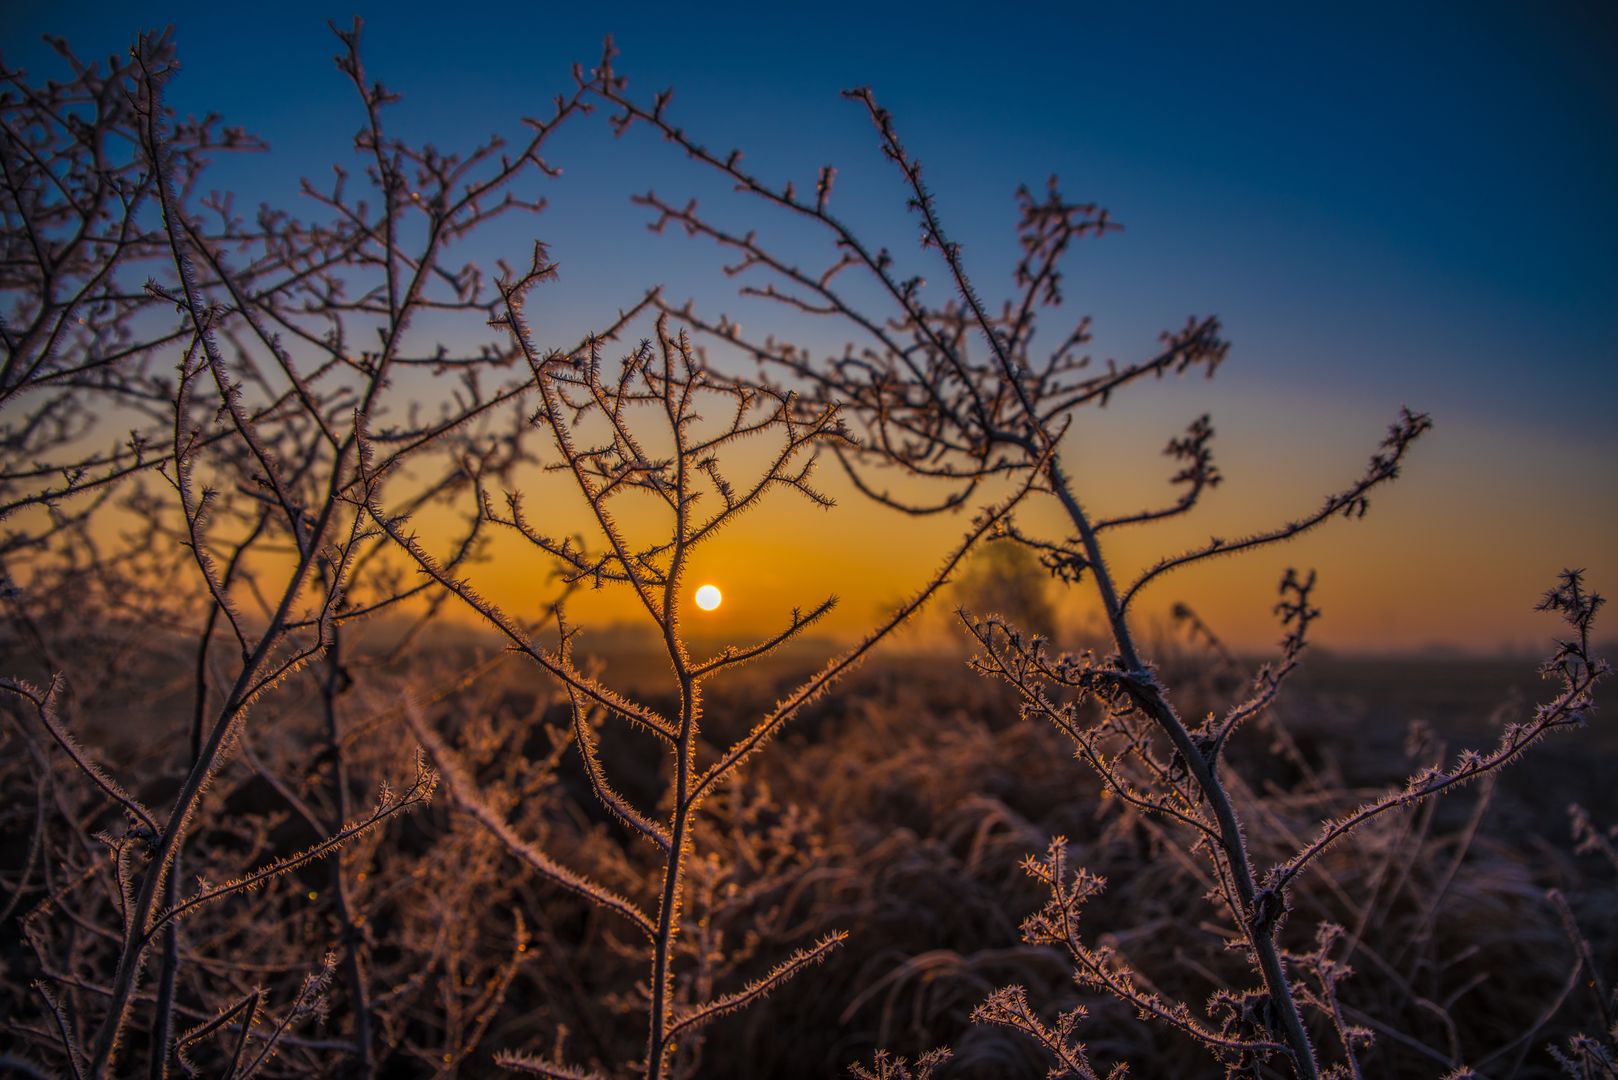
0;23;584;1077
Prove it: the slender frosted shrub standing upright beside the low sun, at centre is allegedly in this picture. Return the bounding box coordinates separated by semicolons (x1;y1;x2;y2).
378;248;1027;1078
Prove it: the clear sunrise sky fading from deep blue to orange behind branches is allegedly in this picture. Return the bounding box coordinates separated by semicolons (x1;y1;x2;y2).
0;2;1618;653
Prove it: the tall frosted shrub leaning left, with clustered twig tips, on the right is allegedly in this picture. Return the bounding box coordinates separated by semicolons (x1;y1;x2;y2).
594;52;1607;1078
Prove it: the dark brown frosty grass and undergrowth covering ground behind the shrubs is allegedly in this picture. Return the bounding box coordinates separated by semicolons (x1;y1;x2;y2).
5;627;1618;1078
